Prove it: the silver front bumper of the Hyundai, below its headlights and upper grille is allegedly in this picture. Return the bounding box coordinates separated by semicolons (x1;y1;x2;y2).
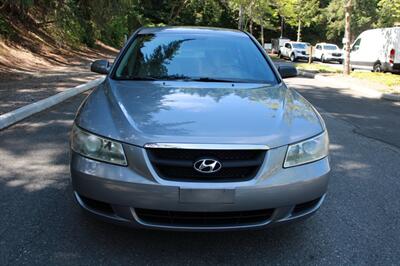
71;144;330;230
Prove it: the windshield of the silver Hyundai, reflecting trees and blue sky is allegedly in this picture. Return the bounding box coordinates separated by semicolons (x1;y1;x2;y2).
114;34;277;84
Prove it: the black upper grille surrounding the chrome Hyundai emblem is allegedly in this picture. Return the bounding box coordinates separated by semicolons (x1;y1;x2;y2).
147;148;265;182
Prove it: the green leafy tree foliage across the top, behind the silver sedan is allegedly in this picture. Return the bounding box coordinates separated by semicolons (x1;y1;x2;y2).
0;0;400;47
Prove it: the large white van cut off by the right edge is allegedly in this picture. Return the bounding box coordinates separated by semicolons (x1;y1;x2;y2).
350;27;400;72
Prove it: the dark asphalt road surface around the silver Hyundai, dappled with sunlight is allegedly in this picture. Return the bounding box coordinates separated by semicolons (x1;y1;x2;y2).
0;78;400;265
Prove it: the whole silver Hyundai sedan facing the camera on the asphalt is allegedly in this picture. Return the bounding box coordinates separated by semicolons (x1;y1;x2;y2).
70;27;330;230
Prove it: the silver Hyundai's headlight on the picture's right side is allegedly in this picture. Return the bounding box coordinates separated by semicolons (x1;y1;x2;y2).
283;131;329;168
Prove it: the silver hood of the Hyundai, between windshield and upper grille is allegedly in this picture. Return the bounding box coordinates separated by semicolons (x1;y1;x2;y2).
76;79;324;148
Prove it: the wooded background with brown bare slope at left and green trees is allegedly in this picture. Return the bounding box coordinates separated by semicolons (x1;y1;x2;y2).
0;0;400;75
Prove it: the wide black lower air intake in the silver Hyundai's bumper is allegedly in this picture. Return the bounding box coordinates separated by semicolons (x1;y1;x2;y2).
135;209;274;227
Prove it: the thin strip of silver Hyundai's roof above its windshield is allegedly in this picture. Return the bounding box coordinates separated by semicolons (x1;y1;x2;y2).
139;26;248;37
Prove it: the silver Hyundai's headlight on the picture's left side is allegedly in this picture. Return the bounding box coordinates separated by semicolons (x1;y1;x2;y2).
71;125;128;166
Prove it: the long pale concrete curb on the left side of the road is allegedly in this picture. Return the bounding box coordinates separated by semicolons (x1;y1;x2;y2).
0;78;104;130
